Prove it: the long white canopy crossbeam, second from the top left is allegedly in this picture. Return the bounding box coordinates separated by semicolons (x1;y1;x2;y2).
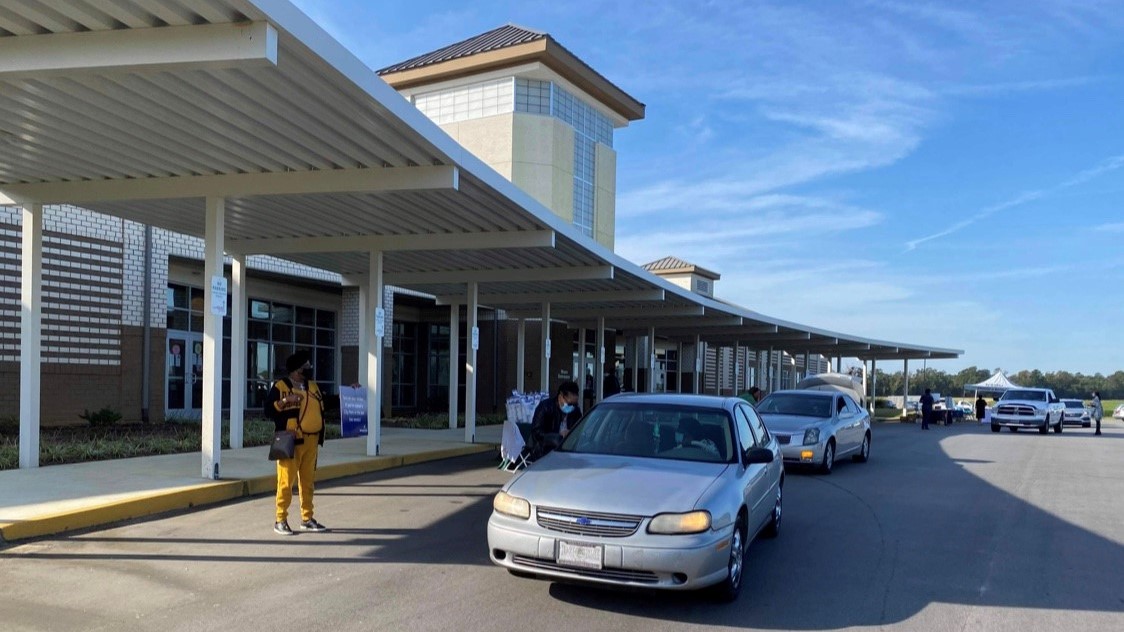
3;165;460;202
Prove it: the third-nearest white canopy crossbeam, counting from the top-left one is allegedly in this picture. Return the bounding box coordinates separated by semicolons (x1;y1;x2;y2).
228;226;555;256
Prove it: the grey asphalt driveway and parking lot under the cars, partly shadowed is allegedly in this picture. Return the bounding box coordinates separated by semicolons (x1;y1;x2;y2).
0;422;1124;632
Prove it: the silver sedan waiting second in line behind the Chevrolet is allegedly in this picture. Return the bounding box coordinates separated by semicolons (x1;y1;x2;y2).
758;390;871;473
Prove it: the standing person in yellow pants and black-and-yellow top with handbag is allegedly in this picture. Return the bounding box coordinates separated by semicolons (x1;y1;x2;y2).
264;351;327;535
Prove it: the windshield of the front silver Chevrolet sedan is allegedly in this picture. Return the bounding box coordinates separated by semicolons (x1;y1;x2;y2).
559;401;737;463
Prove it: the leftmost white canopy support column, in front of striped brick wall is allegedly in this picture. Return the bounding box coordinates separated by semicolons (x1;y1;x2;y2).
19;202;43;469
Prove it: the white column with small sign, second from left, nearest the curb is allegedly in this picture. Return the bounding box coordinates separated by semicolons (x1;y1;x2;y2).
202;197;226;480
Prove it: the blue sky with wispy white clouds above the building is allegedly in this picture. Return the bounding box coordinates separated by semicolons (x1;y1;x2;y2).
297;0;1124;373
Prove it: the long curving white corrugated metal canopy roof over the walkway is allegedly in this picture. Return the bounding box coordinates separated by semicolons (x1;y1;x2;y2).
0;0;961;359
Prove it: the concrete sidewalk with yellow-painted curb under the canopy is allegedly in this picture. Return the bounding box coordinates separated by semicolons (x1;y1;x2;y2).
0;425;504;544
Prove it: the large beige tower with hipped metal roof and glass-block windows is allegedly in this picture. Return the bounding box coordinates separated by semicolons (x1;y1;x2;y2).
379;25;644;250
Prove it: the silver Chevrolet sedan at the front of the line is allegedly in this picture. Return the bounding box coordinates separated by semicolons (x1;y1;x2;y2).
488;395;785;601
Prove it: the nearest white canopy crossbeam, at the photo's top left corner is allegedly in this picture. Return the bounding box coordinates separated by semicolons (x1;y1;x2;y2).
0;21;278;81
